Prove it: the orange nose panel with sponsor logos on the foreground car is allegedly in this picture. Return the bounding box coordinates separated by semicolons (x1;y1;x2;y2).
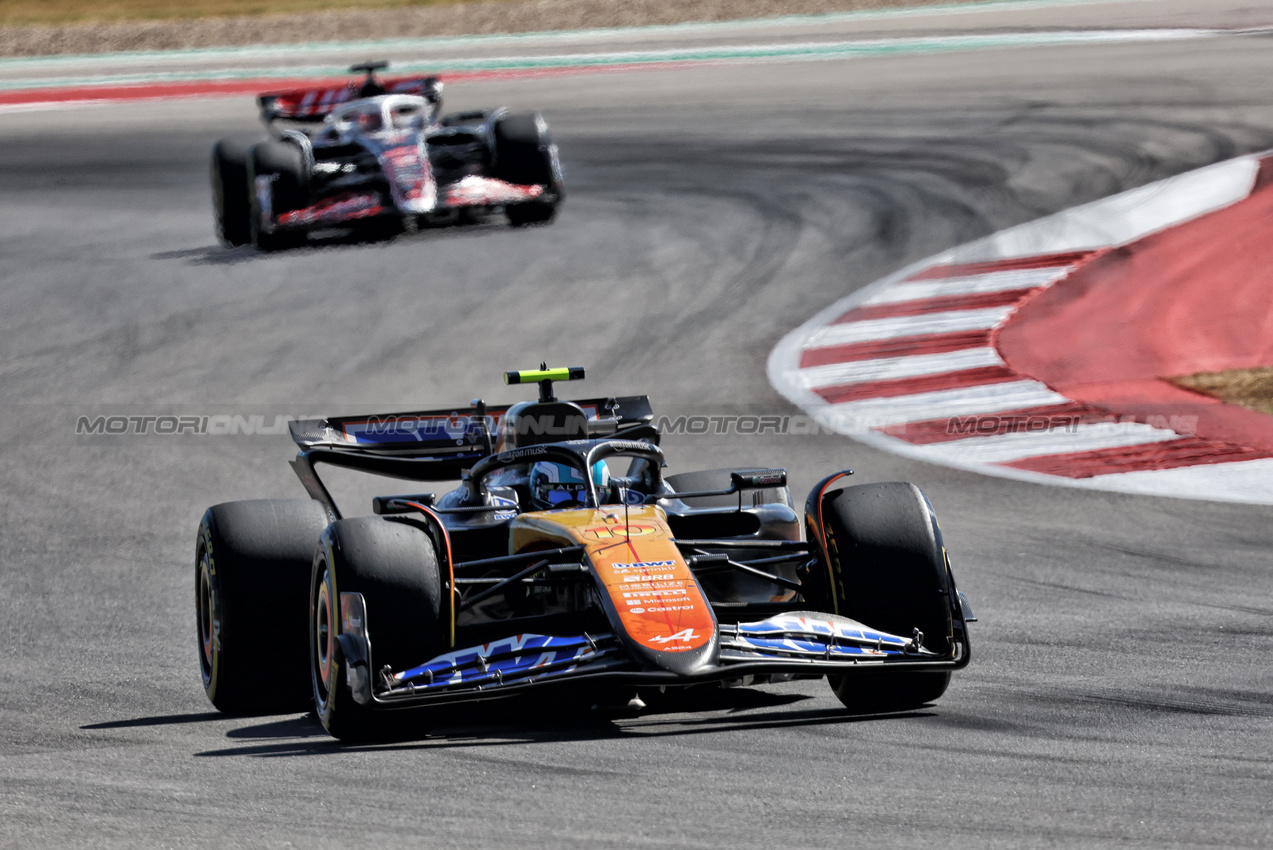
512;505;717;653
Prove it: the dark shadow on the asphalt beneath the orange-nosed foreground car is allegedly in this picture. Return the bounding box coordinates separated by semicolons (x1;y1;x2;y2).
195;688;934;758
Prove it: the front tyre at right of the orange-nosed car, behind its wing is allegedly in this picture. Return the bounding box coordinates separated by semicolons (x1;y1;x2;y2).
824;482;953;711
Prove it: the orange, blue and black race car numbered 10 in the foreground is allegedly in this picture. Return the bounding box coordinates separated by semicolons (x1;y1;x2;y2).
195;368;974;739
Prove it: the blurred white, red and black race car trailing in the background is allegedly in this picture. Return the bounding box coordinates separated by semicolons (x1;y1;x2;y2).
211;62;563;251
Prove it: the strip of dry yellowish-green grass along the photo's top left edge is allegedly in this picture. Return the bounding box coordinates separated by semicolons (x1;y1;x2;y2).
0;0;481;27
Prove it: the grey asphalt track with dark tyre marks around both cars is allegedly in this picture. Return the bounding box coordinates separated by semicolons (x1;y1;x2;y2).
0;3;1273;847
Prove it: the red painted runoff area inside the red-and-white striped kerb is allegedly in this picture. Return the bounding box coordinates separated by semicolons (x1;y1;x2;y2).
995;160;1273;468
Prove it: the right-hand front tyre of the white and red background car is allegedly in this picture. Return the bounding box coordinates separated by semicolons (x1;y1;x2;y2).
494;112;563;226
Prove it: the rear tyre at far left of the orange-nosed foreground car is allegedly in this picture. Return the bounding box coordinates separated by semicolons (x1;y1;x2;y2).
195;500;327;714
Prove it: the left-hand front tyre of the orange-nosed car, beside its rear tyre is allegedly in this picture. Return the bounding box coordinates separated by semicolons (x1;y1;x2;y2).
309;517;443;741
